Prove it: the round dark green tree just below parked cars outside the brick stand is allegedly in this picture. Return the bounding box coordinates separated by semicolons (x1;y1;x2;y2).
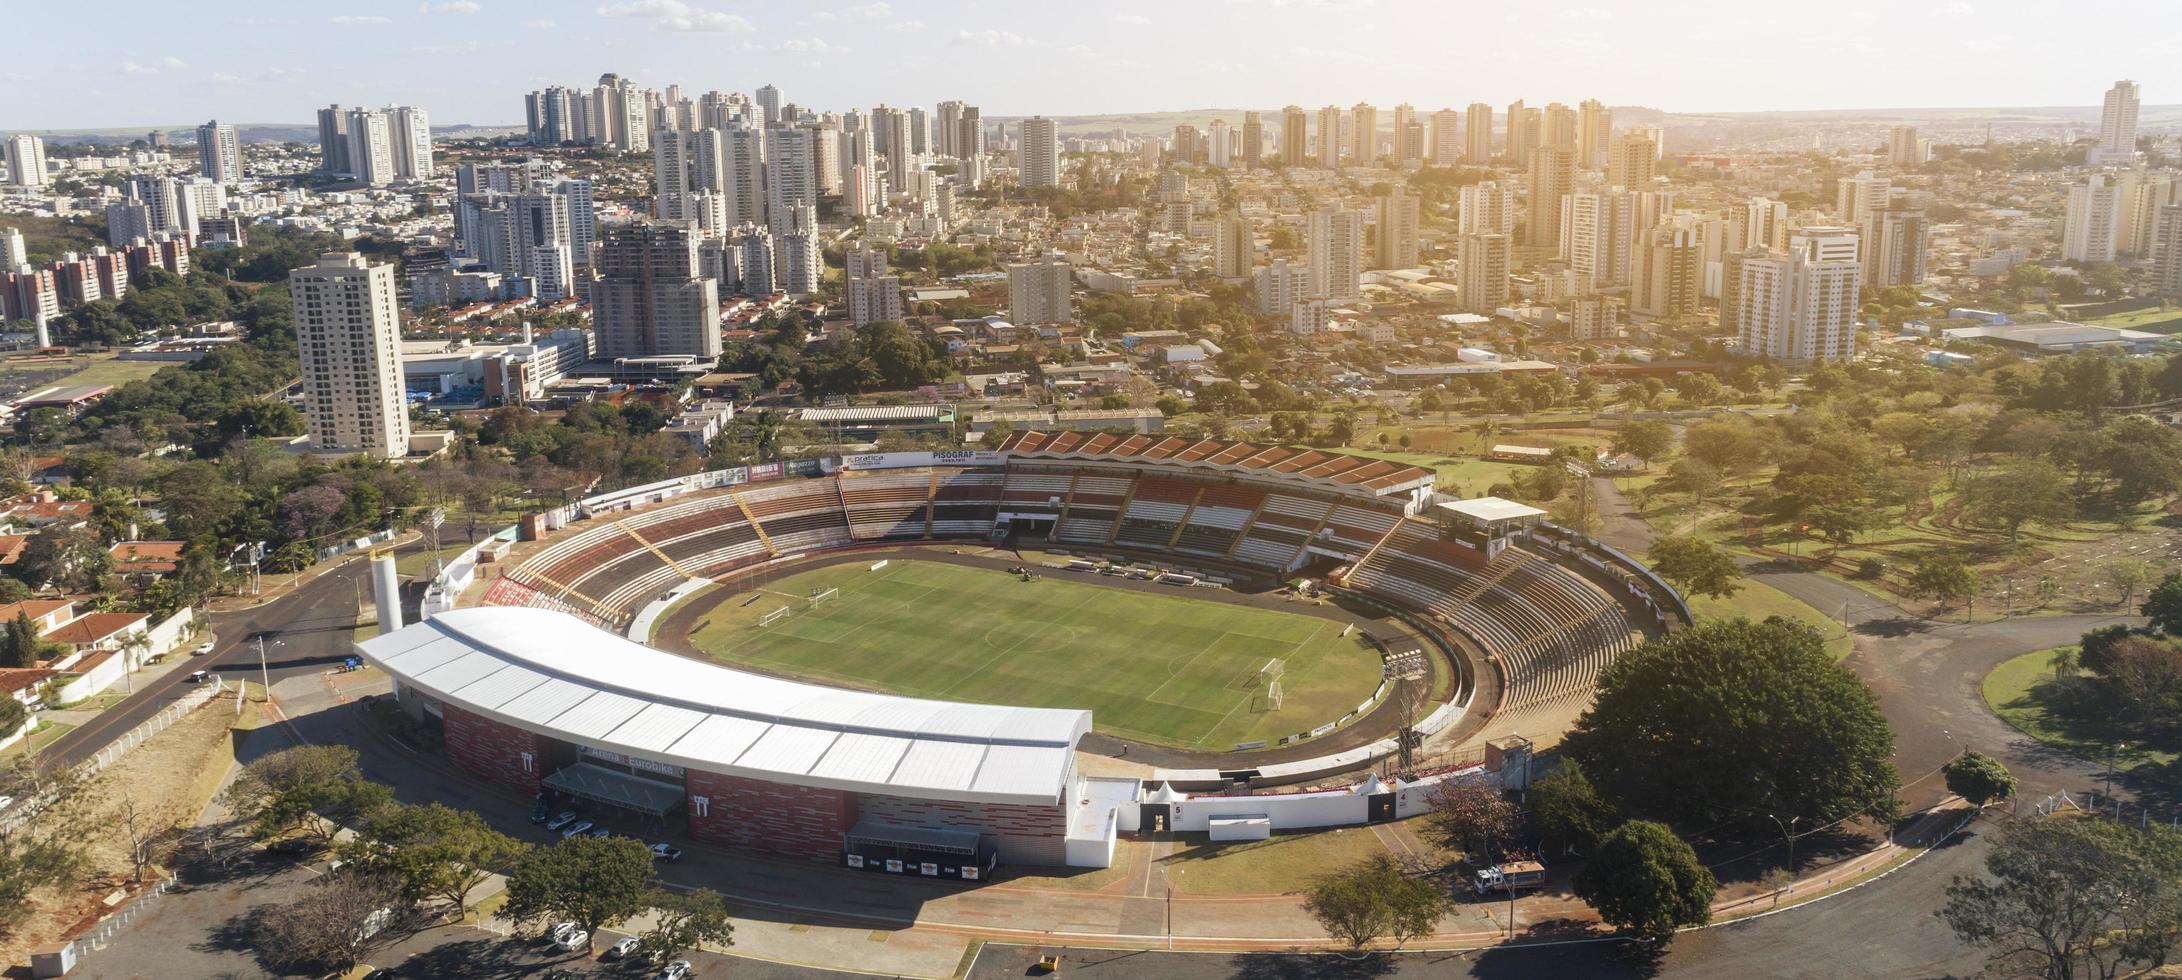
493;836;652;945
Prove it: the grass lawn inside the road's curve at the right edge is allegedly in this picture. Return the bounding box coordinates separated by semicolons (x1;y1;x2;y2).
1986;650;2182;786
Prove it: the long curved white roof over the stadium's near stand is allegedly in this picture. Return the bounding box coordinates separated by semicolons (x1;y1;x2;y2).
356;607;1091;805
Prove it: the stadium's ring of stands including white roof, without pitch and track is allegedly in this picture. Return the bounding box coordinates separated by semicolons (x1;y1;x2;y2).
360;432;1689;877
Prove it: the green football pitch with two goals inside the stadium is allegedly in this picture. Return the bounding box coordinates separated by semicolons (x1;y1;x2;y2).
690;559;1379;749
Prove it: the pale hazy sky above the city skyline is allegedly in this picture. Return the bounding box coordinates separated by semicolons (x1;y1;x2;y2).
0;0;2182;131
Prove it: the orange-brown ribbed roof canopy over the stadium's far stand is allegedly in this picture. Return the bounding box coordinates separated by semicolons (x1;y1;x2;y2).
999;430;1434;495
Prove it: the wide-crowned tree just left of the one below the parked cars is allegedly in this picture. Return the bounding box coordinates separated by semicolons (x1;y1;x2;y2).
343;803;530;912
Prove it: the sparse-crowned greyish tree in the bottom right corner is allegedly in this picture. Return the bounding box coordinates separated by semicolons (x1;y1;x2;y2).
1938;818;2182;980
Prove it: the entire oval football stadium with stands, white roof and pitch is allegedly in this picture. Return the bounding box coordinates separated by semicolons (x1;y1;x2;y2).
358;432;1689;880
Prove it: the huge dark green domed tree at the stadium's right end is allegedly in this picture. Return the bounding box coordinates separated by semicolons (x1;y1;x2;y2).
1562;616;1898;825
